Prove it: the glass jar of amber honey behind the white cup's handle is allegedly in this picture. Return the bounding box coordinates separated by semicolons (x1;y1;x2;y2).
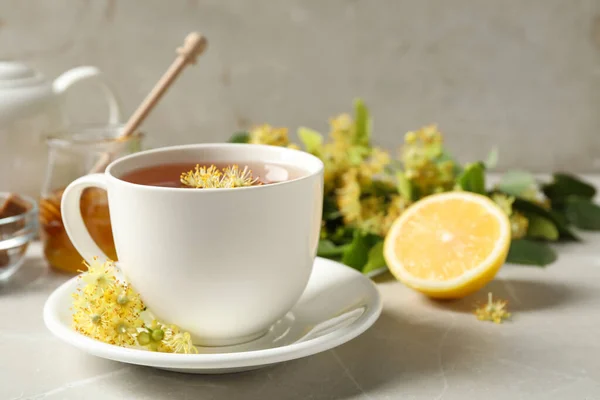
39;125;143;273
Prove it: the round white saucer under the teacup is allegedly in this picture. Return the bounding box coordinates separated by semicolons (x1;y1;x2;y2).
44;258;382;374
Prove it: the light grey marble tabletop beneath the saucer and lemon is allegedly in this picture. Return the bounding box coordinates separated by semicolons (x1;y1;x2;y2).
0;234;600;400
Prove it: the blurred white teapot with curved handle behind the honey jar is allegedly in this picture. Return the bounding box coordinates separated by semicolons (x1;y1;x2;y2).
0;62;121;198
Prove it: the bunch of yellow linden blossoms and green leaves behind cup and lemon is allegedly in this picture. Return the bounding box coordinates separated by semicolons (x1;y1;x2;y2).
241;99;564;273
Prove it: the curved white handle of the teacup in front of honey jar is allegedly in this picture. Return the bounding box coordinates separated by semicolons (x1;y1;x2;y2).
60;174;109;263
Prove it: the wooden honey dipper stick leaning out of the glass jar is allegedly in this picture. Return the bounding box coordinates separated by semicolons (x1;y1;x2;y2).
90;32;208;173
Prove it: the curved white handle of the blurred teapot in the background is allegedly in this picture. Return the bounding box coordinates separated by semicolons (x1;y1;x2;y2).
52;66;121;125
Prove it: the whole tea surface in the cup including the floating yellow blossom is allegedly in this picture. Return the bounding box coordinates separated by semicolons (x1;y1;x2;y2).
120;162;306;189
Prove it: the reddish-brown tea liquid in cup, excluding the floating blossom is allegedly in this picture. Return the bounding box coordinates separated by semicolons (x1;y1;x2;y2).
120;162;306;188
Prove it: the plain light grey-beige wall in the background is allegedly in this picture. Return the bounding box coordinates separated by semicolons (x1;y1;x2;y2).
0;0;600;171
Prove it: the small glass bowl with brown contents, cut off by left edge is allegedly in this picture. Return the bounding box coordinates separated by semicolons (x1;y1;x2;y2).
0;192;38;281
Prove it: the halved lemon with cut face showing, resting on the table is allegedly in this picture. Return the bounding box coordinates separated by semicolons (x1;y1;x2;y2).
384;192;510;298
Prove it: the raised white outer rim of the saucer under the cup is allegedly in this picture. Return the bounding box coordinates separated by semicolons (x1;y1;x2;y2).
43;257;383;370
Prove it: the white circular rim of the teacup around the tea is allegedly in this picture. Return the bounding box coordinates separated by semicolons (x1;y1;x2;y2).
104;143;325;194
